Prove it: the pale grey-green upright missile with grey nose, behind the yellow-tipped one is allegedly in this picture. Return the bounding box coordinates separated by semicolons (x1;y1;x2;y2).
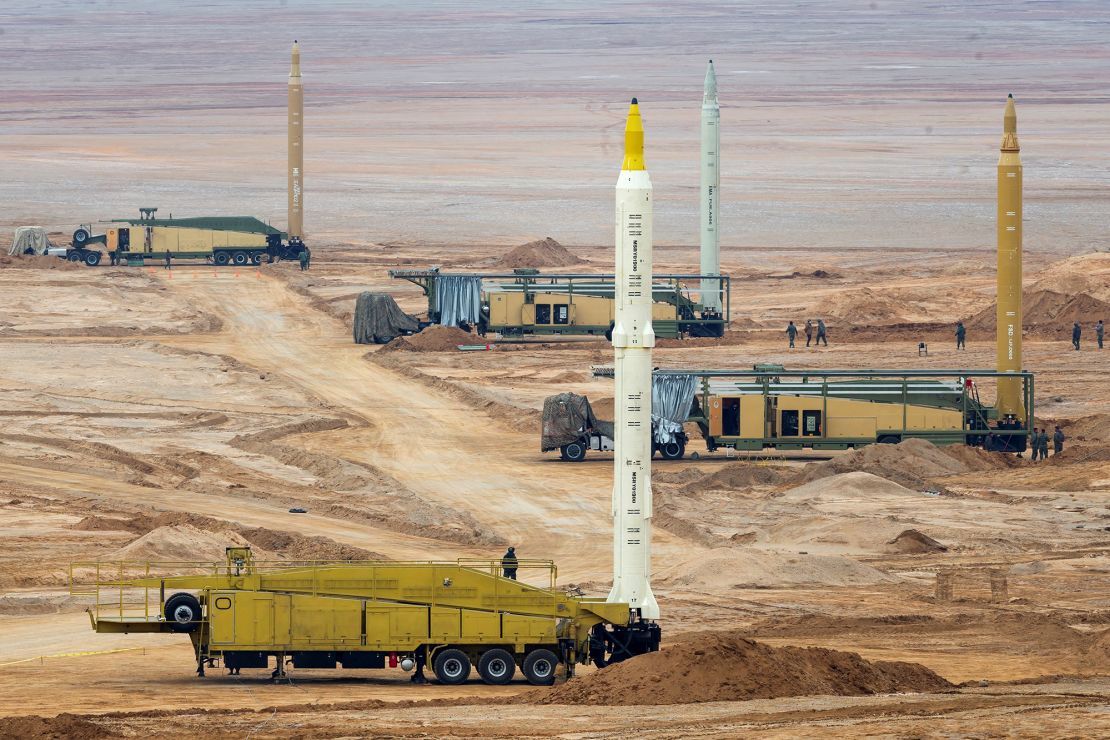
702;59;720;311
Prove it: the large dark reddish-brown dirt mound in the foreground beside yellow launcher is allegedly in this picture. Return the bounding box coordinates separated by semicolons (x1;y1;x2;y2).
518;631;952;706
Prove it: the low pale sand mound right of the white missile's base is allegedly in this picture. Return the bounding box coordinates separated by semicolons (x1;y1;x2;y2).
657;548;897;590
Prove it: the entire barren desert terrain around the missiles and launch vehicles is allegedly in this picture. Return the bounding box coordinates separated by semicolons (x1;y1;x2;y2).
0;0;1110;738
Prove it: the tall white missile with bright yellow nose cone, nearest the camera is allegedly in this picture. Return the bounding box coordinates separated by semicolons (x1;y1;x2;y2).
608;98;659;619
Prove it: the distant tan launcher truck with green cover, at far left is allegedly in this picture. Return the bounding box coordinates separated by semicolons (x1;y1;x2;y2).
58;209;304;267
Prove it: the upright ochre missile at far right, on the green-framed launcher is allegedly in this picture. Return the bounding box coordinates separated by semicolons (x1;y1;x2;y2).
997;95;1026;422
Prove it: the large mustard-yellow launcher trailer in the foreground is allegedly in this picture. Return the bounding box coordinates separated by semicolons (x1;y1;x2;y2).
71;547;658;686
